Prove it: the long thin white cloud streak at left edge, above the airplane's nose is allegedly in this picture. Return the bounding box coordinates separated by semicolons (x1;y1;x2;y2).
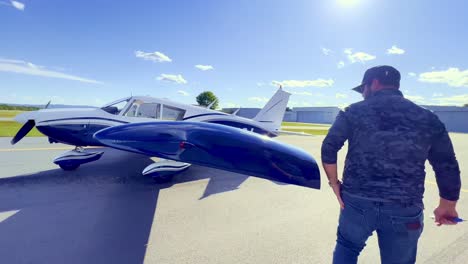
0;59;102;84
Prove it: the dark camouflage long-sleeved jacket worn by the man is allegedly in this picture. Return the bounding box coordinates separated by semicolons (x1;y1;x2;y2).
322;89;461;203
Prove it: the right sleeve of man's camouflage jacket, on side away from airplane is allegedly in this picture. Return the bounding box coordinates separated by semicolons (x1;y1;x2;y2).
428;118;461;201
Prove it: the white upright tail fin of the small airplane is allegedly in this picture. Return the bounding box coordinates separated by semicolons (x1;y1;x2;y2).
253;86;291;130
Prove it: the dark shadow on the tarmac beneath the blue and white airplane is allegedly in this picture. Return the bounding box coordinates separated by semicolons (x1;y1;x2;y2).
0;149;264;263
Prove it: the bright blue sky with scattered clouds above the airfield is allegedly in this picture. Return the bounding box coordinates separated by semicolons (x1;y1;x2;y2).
0;0;468;107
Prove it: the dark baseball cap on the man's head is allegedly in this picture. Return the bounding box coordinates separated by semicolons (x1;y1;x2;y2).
352;65;401;93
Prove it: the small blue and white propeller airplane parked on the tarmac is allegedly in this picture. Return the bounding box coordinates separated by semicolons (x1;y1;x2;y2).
11;87;320;188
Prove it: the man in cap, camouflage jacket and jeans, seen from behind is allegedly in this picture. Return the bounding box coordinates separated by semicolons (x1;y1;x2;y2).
322;66;461;263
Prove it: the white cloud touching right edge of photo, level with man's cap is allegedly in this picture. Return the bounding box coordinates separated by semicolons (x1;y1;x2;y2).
419;68;468;87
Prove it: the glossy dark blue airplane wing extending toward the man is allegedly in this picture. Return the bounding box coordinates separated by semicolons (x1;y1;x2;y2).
94;121;320;189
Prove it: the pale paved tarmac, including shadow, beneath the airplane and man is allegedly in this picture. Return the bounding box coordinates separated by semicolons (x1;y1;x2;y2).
0;134;468;263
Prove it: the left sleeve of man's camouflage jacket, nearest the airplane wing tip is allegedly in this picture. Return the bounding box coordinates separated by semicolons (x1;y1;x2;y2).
322;111;350;164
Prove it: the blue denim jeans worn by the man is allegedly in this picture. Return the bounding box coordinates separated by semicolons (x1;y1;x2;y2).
333;193;424;264
